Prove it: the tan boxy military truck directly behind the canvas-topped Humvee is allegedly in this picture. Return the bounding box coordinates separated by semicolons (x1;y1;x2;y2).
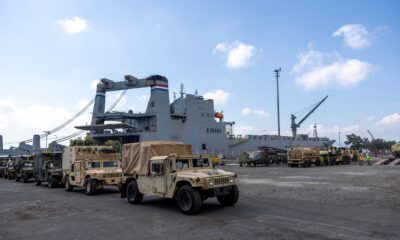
62;146;122;195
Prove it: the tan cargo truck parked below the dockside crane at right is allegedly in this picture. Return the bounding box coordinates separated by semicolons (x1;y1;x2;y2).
287;147;321;167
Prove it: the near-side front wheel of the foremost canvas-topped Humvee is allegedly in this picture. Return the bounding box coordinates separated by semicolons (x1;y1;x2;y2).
176;185;201;214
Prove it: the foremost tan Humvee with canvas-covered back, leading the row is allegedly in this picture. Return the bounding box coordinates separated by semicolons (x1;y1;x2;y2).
121;141;239;214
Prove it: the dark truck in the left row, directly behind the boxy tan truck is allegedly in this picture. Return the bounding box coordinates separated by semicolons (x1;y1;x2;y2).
34;152;63;188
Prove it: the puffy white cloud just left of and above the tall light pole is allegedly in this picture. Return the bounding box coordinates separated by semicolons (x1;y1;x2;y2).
213;41;256;69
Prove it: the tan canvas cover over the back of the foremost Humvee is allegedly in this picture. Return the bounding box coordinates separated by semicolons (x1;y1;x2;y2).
122;141;192;175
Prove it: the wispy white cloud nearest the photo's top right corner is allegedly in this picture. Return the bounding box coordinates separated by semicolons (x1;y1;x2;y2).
332;24;389;49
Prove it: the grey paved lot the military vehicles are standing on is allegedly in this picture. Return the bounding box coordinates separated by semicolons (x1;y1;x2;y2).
0;165;400;240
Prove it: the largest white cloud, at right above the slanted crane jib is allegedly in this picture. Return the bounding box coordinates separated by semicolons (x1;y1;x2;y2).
292;49;374;90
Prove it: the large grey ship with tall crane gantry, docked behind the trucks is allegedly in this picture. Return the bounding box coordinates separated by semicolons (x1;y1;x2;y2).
76;75;333;156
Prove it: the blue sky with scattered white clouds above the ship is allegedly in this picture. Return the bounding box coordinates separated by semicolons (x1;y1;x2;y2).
0;0;400;147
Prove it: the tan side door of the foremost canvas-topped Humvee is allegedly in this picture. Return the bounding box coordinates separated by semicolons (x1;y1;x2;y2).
150;160;167;194
